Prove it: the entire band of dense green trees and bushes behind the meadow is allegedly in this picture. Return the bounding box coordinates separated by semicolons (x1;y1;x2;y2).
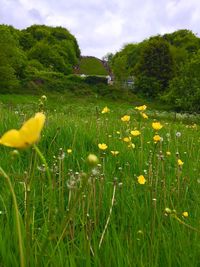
0;25;200;112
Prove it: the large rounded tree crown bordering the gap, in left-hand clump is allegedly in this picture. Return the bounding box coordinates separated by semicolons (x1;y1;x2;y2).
25;25;80;74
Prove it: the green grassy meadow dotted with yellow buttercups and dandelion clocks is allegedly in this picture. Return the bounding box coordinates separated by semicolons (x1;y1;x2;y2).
0;95;200;267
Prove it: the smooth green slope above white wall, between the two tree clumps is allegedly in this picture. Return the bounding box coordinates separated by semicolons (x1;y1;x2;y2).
79;57;108;75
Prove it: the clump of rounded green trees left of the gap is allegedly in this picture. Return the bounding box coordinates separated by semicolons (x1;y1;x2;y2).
0;25;80;93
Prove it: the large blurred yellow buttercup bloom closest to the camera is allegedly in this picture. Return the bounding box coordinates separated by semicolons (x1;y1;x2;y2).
0;112;45;148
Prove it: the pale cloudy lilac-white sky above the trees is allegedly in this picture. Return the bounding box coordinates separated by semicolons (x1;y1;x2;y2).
0;0;200;58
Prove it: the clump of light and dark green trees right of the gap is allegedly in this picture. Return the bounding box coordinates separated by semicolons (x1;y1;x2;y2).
110;30;200;112
